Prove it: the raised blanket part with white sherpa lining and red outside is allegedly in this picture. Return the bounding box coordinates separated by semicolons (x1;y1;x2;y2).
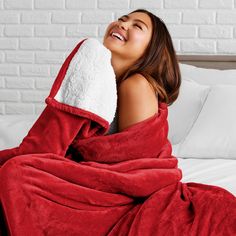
0;38;117;165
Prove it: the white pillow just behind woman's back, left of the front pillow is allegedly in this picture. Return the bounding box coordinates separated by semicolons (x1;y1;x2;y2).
168;79;209;144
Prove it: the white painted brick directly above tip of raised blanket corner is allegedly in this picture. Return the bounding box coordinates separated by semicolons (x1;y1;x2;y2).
66;24;97;37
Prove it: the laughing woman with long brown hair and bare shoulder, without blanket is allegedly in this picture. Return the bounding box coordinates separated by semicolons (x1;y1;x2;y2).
103;9;181;133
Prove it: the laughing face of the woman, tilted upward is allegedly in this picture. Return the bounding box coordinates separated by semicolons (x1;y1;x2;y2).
103;12;152;62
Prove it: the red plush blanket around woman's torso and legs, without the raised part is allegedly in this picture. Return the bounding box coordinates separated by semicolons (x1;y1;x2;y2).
0;103;236;236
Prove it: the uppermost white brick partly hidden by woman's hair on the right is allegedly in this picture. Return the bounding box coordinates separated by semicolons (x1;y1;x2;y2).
154;10;181;24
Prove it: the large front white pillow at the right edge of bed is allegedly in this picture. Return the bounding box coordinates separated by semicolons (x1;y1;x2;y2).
177;85;236;159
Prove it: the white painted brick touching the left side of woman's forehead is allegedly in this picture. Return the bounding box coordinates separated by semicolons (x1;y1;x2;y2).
82;11;112;24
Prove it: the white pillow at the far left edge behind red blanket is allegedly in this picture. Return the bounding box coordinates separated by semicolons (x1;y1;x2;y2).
0;115;37;150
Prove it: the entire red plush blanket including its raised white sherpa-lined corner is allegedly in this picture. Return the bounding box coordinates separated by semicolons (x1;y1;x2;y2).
0;37;236;236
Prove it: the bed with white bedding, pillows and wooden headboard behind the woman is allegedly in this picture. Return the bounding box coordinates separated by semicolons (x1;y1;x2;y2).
0;55;236;195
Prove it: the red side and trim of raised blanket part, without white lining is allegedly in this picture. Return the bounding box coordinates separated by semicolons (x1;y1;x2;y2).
0;39;109;166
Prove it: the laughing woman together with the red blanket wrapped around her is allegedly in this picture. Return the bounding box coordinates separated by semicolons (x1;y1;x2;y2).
0;9;236;236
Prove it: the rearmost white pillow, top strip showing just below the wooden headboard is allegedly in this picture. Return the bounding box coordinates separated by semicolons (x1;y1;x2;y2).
179;63;236;85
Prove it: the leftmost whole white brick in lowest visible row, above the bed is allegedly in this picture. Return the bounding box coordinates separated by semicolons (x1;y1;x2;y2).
5;103;34;115
